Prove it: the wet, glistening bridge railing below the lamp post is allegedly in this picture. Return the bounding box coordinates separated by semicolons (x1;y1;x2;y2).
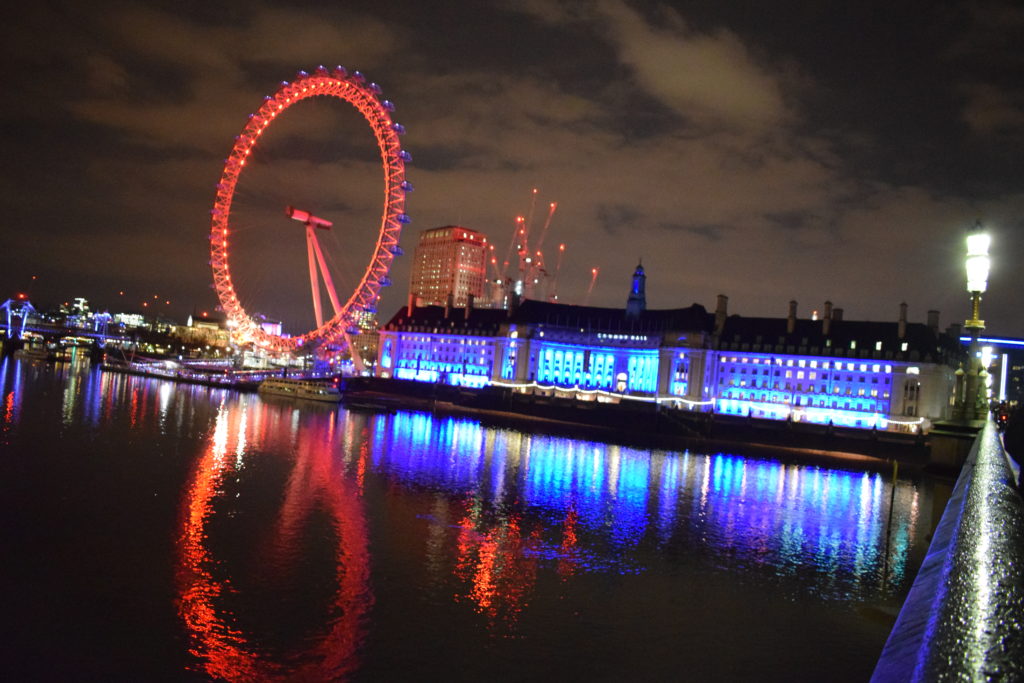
871;422;1024;682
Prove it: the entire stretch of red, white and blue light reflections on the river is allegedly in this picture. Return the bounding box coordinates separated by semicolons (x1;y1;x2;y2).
0;358;932;680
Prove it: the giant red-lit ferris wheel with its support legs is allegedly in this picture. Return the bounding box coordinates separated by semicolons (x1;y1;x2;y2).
210;67;413;358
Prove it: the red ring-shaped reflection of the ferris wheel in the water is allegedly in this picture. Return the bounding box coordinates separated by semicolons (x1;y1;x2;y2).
176;404;373;681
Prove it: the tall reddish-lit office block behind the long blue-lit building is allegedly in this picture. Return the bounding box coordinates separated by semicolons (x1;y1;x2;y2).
410;225;487;307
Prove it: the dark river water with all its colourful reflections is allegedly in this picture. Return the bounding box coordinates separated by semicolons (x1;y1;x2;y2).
0;358;948;681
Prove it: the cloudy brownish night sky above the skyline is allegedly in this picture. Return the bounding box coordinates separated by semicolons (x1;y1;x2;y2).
0;0;1024;336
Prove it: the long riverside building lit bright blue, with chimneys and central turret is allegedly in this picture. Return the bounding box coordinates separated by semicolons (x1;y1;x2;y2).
377;274;962;430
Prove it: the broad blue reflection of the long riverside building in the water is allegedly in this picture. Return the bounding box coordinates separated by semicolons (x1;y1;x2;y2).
373;413;918;598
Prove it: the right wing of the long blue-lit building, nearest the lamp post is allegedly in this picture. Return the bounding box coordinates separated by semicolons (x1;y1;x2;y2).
714;302;959;429
